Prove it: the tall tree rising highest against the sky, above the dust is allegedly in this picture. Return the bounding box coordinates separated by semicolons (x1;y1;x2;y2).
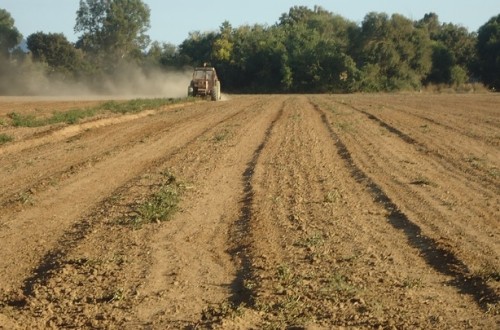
75;0;150;65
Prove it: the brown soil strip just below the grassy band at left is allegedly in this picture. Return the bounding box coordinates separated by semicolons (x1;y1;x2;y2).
0;100;234;208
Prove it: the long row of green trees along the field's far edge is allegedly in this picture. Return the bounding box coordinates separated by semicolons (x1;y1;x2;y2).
0;0;500;93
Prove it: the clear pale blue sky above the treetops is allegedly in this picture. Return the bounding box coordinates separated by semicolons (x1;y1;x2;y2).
0;0;500;45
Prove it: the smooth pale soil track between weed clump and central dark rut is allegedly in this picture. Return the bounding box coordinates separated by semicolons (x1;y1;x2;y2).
134;97;290;328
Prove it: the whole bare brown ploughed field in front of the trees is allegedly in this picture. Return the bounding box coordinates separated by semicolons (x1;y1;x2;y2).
0;94;500;329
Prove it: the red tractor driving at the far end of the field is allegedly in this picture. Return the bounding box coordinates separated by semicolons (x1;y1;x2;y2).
188;66;221;101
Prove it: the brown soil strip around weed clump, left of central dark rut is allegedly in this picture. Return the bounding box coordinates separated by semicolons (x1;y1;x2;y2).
0;94;284;326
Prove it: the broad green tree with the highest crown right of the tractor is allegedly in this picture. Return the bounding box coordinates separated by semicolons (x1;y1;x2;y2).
278;6;358;92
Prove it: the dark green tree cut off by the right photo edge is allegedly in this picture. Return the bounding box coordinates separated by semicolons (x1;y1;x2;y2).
477;14;500;90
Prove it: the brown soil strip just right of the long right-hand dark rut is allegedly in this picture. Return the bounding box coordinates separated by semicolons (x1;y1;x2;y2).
314;96;499;273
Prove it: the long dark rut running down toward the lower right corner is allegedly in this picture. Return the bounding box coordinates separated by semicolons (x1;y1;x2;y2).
311;102;500;311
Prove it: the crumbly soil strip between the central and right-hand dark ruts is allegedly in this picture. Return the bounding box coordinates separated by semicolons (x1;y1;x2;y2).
218;97;491;328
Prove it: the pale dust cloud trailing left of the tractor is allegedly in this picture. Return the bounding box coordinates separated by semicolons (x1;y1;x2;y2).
0;59;192;99
